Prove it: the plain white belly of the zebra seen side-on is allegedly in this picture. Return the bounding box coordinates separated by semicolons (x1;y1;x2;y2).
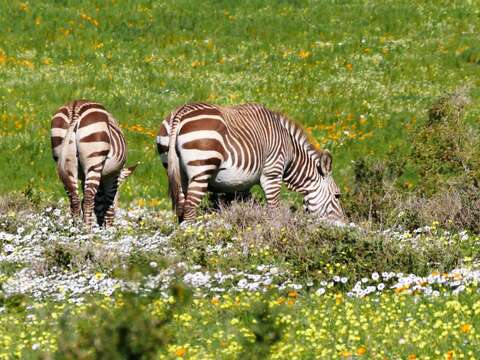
208;167;260;192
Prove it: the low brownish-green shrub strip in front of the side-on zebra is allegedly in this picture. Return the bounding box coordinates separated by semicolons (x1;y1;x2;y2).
172;203;475;281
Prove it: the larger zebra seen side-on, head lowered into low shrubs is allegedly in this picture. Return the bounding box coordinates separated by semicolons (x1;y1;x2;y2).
157;103;344;222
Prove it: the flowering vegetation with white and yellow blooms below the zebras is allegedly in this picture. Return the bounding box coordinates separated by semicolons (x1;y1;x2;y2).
0;200;480;359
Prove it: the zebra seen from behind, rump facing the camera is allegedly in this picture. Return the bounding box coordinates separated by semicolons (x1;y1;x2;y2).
51;100;136;228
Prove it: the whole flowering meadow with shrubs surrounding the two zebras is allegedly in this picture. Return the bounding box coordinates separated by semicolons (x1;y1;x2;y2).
0;0;480;359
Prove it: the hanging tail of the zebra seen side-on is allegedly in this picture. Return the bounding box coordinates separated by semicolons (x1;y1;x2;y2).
167;114;183;219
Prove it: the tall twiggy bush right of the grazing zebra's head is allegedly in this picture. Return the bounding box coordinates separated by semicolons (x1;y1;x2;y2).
344;86;480;232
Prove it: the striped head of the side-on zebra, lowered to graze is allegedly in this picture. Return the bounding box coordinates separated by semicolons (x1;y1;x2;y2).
305;150;345;223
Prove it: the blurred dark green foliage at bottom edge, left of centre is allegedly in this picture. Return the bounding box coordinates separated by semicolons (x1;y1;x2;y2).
55;285;191;359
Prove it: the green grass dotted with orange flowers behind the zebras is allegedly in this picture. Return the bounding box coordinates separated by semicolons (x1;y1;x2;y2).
0;0;480;201
